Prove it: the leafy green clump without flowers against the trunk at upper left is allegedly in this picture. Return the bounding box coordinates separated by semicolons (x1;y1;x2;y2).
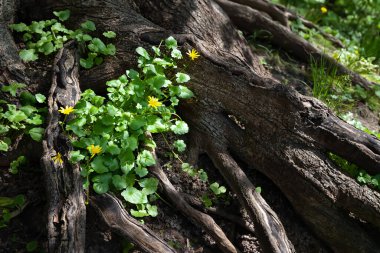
9;10;116;69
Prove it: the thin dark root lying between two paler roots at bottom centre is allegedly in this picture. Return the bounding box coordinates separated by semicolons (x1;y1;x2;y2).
182;193;255;234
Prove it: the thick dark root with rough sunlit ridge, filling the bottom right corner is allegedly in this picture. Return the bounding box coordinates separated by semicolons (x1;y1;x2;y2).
280;144;380;252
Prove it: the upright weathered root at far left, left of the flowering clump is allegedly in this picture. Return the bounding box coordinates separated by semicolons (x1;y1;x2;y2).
41;45;86;252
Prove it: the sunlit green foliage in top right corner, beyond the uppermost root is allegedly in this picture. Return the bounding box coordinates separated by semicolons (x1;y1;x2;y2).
274;0;380;63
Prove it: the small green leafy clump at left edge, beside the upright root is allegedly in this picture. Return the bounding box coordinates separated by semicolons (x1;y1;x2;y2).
0;83;46;152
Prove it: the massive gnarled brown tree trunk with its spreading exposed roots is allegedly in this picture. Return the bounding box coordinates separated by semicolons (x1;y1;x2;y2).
0;0;380;252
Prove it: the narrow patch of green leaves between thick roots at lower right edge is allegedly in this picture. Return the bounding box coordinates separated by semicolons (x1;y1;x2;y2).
328;153;380;191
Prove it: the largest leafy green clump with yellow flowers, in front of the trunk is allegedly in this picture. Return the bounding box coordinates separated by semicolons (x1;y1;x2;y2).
65;37;194;217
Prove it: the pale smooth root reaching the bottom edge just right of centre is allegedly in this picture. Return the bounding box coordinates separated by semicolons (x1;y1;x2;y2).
207;145;294;253
